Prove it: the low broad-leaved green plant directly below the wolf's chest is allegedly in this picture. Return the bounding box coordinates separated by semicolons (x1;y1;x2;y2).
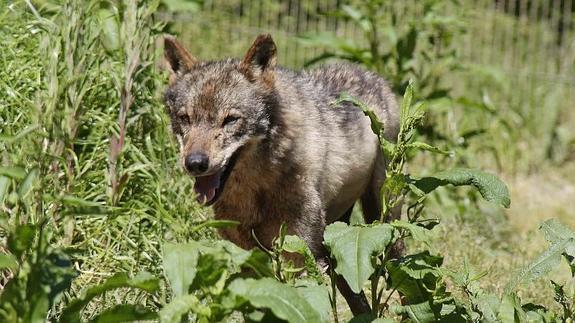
159;231;330;322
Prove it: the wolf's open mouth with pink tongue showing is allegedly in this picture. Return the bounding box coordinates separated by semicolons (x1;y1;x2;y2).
194;148;241;205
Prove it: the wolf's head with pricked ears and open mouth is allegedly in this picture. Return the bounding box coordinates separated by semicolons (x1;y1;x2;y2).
164;35;277;204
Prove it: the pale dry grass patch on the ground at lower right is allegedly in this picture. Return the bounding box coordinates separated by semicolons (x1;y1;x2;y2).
424;165;575;306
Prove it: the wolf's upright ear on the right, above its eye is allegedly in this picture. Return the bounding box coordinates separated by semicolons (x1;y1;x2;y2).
240;34;277;81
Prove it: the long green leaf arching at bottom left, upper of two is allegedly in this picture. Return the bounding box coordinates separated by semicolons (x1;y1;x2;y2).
60;272;160;322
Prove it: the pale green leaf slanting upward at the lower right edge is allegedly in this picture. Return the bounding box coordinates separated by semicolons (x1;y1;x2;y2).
505;238;575;294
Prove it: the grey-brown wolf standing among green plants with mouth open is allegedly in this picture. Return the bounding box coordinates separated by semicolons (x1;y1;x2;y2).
164;34;399;314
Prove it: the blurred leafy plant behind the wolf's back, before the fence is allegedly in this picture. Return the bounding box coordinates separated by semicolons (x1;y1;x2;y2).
300;0;463;101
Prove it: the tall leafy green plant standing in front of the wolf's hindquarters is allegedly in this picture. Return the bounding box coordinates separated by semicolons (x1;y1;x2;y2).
324;81;510;321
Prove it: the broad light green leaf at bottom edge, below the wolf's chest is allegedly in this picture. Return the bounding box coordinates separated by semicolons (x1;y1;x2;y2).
229;278;322;323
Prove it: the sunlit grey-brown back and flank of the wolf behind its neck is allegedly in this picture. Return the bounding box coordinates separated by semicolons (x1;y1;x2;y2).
276;64;399;223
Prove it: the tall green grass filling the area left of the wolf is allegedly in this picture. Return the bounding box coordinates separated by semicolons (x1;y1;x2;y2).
0;0;212;313
